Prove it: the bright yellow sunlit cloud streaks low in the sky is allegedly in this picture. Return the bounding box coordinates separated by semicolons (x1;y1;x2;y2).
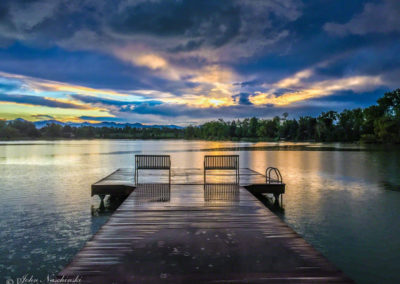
0;65;383;122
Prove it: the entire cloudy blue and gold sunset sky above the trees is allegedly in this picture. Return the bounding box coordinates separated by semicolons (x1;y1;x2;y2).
0;0;400;125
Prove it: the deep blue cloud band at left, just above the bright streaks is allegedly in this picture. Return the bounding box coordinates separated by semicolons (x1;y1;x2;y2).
0;43;177;91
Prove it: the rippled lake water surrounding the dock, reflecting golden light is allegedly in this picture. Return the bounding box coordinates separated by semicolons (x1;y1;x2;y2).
0;140;400;283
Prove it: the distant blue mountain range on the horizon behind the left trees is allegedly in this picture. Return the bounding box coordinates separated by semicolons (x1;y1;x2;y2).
10;118;183;129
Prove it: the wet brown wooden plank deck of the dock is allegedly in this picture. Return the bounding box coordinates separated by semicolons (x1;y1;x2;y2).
59;169;352;283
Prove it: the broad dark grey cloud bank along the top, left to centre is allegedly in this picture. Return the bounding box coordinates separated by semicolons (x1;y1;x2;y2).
0;0;301;55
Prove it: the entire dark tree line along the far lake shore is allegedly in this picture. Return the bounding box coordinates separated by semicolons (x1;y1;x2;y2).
0;89;400;143
